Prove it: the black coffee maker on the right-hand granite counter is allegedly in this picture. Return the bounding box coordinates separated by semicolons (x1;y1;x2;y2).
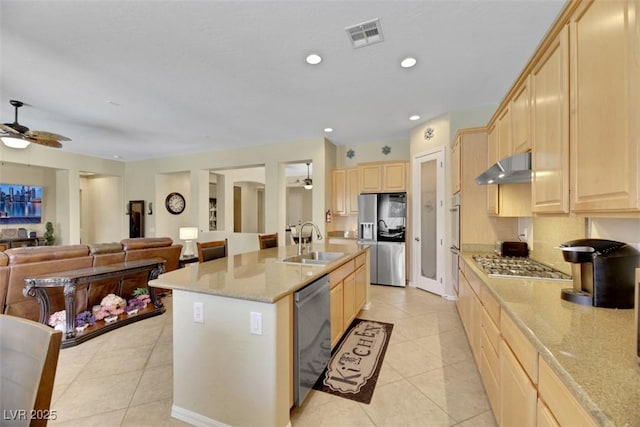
558;239;640;308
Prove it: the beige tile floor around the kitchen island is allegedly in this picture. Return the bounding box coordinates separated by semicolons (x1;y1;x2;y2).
49;286;496;427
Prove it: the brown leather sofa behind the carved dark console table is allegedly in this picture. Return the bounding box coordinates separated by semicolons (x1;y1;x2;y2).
0;237;182;321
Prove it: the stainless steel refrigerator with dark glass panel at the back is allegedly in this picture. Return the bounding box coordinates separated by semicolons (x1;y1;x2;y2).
358;193;407;286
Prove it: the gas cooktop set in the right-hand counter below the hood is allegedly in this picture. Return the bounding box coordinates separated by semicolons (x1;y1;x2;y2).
473;255;571;281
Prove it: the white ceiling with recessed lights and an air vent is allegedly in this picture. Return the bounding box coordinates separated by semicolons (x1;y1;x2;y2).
0;0;564;161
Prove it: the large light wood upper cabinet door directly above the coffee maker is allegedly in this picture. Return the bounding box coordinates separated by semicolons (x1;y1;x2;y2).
569;0;640;213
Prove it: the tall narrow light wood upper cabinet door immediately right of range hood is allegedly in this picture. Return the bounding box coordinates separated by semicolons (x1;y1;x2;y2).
531;27;569;213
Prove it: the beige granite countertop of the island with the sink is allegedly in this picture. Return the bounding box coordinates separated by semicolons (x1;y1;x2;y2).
149;243;369;303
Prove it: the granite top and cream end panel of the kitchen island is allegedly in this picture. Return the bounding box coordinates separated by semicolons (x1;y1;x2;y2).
149;243;369;427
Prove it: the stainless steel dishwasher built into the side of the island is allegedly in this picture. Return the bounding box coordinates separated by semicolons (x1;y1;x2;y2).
293;275;331;406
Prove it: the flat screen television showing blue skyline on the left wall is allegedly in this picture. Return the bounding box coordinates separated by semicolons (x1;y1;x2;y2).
0;183;42;225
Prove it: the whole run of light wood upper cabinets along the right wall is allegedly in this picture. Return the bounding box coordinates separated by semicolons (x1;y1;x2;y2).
487;0;640;217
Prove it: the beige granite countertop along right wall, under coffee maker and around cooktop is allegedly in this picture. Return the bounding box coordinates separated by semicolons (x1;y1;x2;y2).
462;253;640;426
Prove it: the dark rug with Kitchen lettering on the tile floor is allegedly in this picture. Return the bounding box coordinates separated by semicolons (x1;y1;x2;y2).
313;319;393;404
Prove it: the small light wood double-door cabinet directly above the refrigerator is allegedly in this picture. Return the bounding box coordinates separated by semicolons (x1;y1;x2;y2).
358;162;407;193
